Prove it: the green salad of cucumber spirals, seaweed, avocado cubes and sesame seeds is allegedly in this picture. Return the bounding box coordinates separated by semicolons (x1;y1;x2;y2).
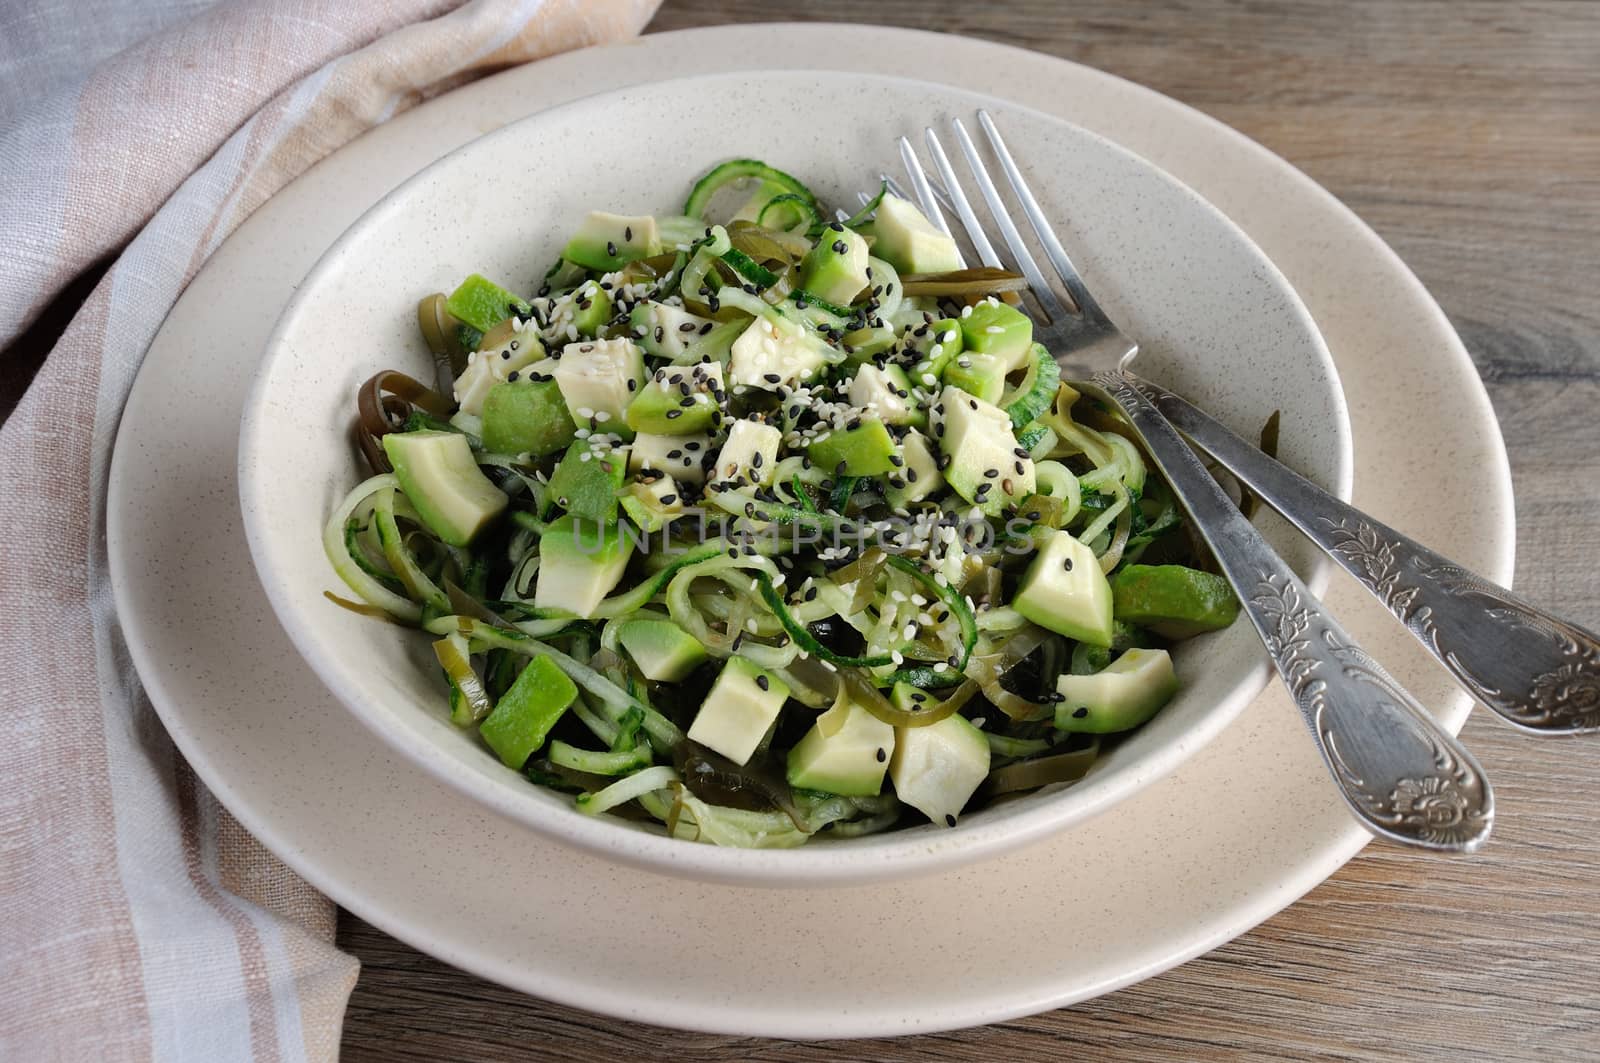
325;160;1238;847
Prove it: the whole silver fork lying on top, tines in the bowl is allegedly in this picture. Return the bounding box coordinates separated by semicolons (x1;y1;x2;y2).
891;110;1494;852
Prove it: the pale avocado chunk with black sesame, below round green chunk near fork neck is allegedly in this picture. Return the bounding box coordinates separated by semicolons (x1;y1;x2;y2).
930;386;1037;517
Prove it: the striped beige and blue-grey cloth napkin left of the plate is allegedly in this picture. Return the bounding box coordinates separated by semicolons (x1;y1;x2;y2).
0;0;654;1063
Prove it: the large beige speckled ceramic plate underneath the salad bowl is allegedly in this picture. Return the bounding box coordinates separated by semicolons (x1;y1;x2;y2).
109;26;1512;1037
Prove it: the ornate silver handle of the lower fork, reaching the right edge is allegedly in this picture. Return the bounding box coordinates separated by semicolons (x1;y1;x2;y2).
1138;371;1600;735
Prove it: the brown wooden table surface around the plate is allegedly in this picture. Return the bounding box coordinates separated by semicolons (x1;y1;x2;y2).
339;0;1600;1061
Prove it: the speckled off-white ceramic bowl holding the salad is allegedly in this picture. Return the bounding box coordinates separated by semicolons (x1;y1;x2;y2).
240;72;1352;885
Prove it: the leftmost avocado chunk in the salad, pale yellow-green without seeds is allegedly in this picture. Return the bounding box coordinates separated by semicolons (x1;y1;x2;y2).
384;432;509;546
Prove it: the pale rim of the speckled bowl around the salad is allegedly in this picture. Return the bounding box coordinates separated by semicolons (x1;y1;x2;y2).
237;69;1354;887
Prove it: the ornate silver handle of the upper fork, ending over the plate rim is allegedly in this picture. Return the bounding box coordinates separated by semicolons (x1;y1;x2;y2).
1093;373;1494;852
